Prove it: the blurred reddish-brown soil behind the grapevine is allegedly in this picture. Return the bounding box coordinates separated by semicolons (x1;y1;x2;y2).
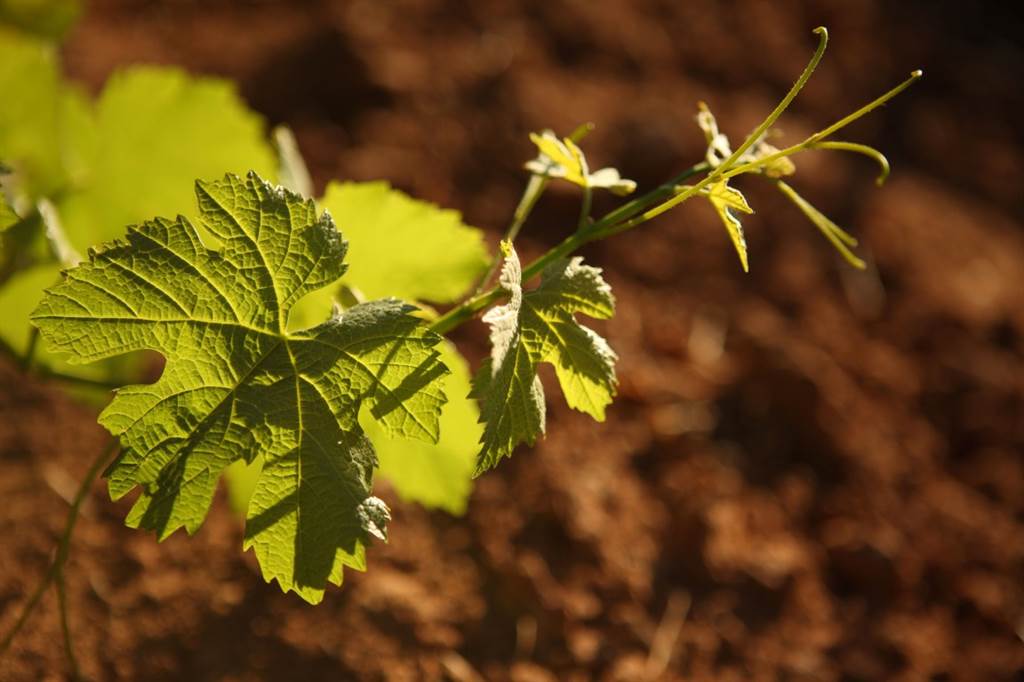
0;0;1024;682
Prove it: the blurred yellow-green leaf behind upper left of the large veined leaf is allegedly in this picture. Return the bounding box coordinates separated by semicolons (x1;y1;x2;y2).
58;67;275;251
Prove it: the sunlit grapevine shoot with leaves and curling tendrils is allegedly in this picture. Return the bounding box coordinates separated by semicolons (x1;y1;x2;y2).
0;19;921;667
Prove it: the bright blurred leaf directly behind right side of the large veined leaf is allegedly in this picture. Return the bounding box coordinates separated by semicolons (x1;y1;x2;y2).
286;182;487;513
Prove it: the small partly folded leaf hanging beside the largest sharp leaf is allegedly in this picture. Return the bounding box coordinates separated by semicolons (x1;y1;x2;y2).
473;243;617;473
